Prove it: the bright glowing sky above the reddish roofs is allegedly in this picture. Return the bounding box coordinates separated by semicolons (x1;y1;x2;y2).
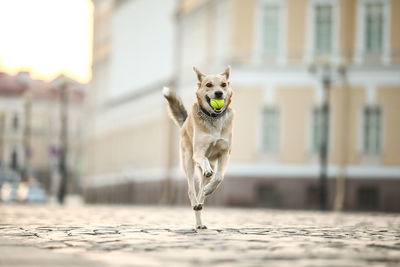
0;0;93;83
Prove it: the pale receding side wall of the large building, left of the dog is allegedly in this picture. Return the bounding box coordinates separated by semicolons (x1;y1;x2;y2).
85;0;178;203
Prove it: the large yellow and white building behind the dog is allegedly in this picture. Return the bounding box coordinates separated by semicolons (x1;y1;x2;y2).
85;0;400;211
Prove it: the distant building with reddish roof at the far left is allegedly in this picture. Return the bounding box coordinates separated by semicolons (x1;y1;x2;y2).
0;72;84;197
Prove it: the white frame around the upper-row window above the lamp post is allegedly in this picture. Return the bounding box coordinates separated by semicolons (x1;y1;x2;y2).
304;0;340;63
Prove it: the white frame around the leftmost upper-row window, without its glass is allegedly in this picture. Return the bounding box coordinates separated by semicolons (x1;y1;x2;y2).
253;0;287;65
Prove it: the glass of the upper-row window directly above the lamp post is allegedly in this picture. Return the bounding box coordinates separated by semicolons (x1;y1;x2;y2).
314;4;333;54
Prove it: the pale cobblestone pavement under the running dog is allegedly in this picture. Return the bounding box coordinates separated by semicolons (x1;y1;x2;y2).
0;205;400;266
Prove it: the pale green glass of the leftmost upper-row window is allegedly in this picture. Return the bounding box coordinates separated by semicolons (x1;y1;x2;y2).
263;5;280;54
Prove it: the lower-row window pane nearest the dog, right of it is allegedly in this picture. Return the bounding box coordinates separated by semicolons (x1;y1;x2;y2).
262;108;279;152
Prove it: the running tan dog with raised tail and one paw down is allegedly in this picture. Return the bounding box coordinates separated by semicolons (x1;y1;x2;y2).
163;66;234;229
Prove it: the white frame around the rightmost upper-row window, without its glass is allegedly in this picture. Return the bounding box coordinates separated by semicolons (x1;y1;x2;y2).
353;0;391;65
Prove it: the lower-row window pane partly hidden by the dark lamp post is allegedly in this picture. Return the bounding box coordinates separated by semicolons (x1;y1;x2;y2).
311;107;329;152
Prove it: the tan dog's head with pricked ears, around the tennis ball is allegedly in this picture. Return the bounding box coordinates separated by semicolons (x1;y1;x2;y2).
193;66;232;114
